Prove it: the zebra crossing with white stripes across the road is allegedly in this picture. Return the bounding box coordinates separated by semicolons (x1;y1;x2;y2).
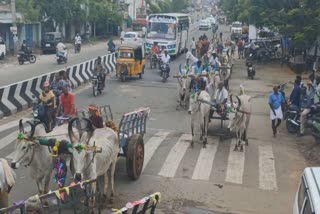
0;121;278;191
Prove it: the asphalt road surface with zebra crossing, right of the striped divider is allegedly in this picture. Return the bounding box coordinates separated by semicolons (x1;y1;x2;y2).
0;22;310;214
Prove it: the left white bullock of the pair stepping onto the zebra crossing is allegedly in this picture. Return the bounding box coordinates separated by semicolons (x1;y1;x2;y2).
188;91;211;148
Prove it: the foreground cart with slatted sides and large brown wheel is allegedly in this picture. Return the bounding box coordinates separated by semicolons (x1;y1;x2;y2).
78;105;150;180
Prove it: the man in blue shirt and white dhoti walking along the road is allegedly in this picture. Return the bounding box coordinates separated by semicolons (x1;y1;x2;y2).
269;86;285;137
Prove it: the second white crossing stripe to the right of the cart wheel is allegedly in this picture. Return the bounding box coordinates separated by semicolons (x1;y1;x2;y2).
158;134;192;178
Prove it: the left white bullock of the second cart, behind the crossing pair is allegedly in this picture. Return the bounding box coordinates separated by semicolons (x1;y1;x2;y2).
177;65;191;108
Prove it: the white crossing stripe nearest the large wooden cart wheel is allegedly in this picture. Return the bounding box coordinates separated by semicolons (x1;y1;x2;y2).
142;132;170;172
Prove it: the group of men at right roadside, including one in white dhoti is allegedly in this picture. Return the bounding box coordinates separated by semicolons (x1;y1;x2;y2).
269;74;320;136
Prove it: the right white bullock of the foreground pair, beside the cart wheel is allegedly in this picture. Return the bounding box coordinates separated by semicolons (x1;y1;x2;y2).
71;120;120;201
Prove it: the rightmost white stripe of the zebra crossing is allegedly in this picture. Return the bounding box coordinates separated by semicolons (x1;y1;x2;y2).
259;144;277;190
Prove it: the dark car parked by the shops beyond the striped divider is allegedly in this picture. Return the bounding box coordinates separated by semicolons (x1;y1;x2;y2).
41;32;63;54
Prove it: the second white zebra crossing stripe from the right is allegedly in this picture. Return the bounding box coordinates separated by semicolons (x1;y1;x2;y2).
226;139;245;184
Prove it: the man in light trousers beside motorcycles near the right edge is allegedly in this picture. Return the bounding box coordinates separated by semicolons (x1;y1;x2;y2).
299;86;311;137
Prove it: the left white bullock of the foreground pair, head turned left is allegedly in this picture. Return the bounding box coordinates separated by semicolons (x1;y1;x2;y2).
11;120;70;195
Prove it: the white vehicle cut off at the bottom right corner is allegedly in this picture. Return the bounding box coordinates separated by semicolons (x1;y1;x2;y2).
293;167;320;214
